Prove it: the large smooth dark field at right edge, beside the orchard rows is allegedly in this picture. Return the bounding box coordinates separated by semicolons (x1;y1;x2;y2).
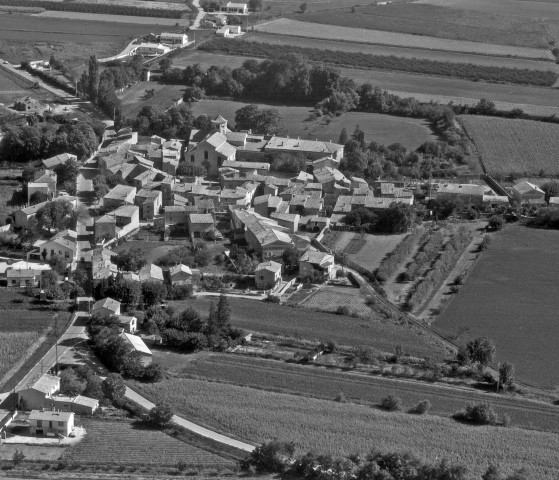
433;226;559;391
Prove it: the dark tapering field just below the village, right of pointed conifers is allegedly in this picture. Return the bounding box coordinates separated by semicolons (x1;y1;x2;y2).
169;297;446;359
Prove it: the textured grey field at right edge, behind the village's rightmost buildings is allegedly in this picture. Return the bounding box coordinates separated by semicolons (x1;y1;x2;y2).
459;115;559;176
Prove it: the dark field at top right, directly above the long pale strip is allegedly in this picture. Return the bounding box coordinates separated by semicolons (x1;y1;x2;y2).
298;3;547;49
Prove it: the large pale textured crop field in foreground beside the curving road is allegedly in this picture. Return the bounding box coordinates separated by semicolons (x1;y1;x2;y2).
137;378;559;480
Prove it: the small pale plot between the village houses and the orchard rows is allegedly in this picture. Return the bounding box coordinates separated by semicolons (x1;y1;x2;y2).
323;231;406;272
